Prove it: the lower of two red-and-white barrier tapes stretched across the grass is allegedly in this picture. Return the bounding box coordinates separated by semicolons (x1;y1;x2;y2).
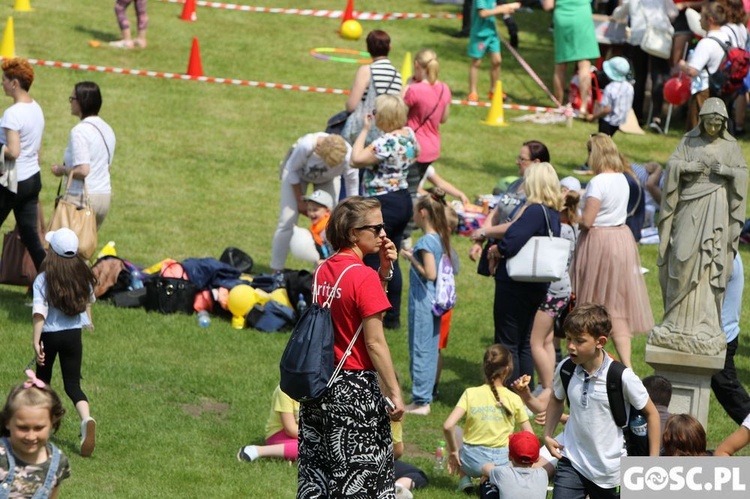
28;59;557;112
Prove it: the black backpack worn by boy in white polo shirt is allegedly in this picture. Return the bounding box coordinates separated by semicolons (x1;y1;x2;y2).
560;358;649;456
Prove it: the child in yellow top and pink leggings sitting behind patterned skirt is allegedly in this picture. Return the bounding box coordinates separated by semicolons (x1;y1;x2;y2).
237;386;299;462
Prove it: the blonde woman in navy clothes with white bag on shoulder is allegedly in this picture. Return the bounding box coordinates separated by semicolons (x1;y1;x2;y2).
488;163;562;382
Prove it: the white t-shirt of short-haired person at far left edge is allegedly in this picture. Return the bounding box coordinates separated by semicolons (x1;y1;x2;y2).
0;100;44;182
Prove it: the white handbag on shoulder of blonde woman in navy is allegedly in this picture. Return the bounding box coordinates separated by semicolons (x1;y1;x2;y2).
505;205;570;282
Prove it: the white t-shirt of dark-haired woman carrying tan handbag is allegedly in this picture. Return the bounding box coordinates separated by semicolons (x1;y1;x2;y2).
63;116;117;194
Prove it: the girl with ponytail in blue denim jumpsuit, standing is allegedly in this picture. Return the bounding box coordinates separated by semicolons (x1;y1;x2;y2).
401;188;458;416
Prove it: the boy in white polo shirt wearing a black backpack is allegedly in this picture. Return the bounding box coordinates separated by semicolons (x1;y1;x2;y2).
544;304;661;499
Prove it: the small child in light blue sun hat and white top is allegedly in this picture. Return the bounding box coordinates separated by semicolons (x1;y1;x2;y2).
588;57;635;136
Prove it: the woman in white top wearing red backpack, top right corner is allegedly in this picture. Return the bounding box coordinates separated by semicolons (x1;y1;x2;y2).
676;3;729;130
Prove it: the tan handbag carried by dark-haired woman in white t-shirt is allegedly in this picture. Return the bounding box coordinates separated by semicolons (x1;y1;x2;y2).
48;172;97;260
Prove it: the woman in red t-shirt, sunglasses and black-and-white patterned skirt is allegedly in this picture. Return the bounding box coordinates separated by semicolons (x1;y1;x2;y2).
297;196;404;497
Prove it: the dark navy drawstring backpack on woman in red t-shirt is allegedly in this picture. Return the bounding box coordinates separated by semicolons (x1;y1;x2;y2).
279;263;362;402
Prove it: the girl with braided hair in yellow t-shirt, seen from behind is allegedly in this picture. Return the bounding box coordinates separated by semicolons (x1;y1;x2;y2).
443;345;533;491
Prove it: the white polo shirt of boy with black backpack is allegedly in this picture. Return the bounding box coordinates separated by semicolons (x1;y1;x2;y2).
554;355;648;489
